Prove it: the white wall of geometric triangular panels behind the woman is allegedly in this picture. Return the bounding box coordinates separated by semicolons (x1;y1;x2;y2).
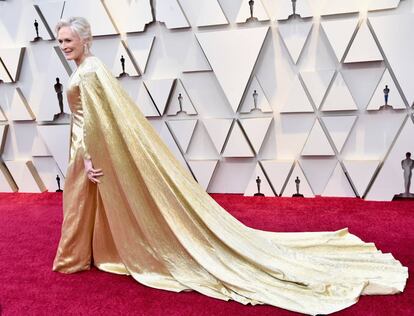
0;0;414;200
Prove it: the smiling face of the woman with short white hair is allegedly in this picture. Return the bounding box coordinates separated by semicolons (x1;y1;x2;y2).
58;26;85;64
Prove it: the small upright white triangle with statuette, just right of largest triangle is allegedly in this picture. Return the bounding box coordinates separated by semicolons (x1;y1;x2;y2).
240;76;273;113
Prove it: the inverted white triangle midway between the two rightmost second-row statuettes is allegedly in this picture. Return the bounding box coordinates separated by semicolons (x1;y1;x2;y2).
301;70;335;108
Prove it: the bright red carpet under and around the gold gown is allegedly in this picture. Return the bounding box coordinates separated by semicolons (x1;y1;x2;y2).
0;193;414;316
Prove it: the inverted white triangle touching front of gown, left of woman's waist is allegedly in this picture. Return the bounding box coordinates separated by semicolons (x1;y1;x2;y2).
37;125;70;174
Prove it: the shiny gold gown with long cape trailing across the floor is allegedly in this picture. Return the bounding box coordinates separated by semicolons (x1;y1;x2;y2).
53;56;408;314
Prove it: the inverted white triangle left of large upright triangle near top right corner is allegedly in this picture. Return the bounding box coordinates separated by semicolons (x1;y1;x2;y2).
321;15;358;61
